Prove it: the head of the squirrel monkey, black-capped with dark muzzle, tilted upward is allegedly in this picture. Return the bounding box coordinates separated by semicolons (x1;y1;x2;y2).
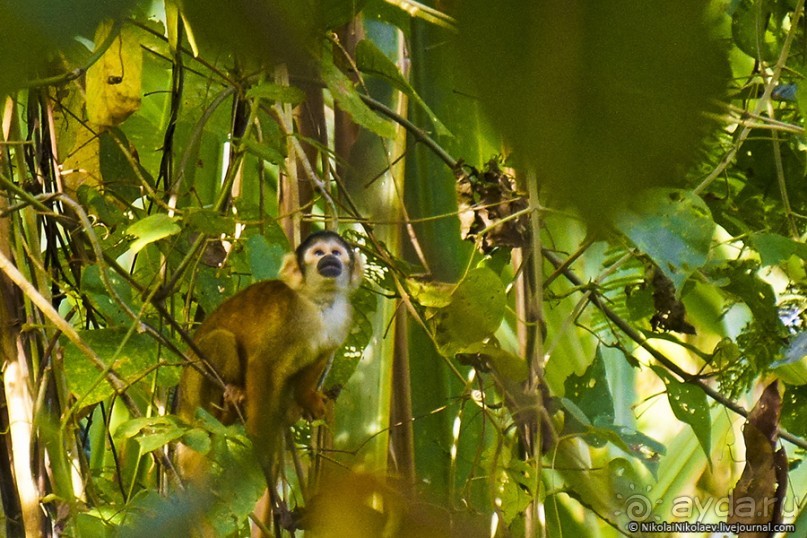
280;231;364;293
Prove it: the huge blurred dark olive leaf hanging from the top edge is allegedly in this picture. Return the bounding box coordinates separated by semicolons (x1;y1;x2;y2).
454;0;731;222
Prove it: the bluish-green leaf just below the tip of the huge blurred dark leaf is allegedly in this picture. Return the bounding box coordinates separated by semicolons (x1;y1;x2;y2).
616;189;715;297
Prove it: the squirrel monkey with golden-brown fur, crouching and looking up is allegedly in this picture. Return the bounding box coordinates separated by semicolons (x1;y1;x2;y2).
177;231;363;486
